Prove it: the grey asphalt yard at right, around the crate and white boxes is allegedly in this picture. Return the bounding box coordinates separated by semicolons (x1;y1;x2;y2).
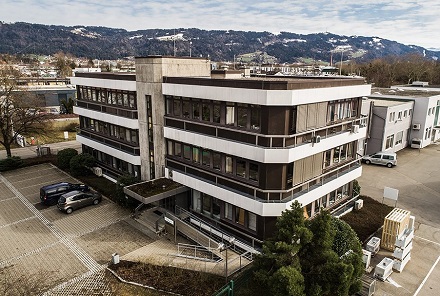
358;144;440;296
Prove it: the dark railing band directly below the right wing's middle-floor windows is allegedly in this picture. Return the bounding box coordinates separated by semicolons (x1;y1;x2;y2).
167;159;361;203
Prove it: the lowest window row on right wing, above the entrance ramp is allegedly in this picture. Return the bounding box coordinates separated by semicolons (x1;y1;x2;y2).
192;190;257;231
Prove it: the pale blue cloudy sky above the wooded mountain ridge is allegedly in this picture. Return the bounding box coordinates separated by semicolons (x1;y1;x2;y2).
0;0;440;50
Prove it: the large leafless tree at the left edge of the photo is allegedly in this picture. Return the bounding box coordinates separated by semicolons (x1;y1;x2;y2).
0;65;51;157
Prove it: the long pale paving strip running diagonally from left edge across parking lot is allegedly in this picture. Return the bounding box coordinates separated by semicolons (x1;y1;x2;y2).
0;174;102;271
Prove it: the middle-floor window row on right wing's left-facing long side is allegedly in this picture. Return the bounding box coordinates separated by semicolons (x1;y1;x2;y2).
167;140;259;181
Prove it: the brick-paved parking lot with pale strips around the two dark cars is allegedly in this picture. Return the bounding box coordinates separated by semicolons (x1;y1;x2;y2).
0;164;152;295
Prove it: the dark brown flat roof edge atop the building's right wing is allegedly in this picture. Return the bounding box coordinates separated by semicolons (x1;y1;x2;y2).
163;77;365;90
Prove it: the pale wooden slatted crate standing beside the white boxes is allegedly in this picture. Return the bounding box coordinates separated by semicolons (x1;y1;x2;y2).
380;208;411;252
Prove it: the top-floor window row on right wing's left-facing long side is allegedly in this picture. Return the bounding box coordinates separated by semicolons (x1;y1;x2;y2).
165;96;261;131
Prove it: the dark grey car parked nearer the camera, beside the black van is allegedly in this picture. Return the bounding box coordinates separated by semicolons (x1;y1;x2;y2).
57;190;102;214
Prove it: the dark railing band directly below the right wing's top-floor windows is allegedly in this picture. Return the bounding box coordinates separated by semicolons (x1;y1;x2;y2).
165;116;366;148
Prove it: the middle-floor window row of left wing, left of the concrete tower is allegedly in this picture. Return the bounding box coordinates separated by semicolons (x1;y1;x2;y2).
80;117;139;145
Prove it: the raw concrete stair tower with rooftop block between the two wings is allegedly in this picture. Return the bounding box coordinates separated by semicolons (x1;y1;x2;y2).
136;56;211;180
